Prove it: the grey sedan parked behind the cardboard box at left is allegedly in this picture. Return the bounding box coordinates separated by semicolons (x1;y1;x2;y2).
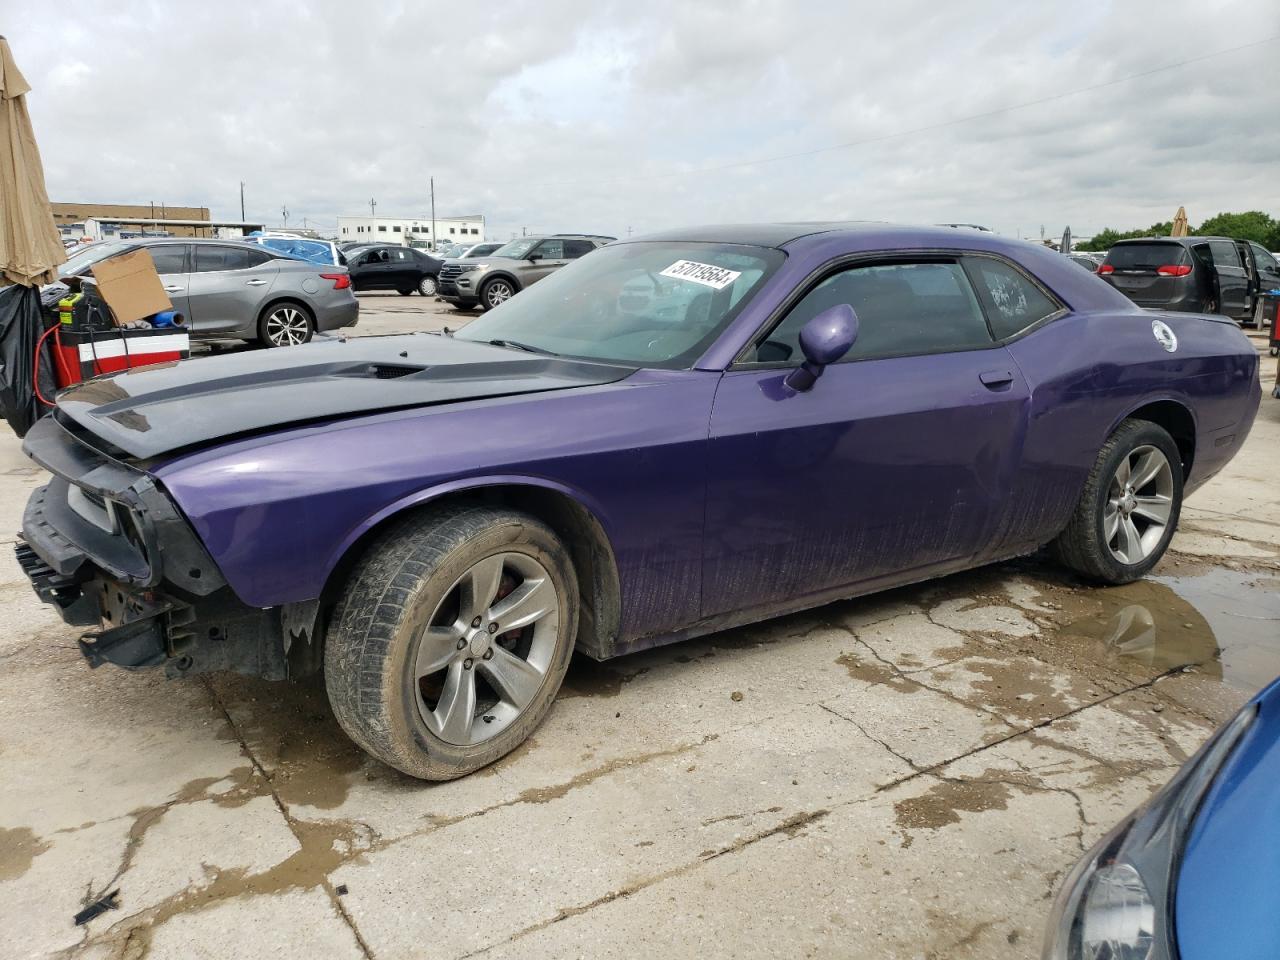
50;238;360;347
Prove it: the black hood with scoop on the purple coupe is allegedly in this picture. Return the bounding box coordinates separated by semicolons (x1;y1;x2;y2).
58;334;634;460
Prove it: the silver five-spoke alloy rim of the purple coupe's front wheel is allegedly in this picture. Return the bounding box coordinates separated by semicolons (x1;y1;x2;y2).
412;553;561;746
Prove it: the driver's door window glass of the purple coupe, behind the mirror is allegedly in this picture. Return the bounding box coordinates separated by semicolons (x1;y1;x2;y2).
755;261;992;364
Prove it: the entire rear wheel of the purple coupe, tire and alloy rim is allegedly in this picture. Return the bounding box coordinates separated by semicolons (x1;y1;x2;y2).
1053;420;1183;584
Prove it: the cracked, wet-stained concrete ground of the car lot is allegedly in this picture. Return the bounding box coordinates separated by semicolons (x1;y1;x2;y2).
0;296;1280;960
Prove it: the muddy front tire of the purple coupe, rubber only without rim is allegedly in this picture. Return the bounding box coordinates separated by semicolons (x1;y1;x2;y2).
324;506;579;781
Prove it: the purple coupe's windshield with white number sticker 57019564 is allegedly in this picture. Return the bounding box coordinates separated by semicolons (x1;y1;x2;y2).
456;241;783;369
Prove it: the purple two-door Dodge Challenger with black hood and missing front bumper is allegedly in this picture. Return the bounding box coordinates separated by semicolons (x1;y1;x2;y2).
17;224;1261;780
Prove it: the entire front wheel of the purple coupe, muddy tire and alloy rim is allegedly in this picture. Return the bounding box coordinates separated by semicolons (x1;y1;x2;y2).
324;506;577;780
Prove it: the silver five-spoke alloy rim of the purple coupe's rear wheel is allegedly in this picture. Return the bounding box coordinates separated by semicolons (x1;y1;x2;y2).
1102;444;1174;564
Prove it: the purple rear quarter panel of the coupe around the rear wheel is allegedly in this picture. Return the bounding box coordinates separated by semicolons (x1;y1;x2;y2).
991;310;1260;556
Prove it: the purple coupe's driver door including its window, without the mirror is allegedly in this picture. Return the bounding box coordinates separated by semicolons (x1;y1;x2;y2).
703;257;1028;617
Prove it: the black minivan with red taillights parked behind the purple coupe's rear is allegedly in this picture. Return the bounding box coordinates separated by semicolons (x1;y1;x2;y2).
1098;237;1280;324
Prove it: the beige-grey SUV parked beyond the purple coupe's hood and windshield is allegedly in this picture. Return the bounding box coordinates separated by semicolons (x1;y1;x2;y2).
439;233;617;310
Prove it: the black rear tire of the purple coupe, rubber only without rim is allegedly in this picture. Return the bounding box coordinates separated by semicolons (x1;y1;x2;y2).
1051;420;1183;584
